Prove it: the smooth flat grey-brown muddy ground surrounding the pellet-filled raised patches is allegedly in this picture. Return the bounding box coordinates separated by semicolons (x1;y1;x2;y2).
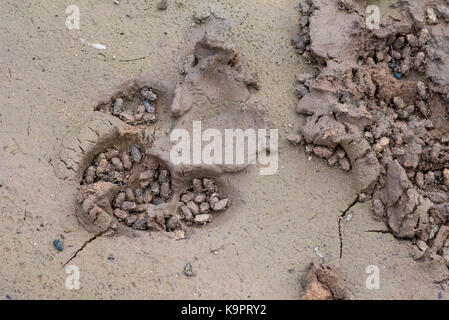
0;0;449;299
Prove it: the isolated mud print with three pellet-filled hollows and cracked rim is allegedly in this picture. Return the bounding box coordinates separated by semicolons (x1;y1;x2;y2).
51;34;266;238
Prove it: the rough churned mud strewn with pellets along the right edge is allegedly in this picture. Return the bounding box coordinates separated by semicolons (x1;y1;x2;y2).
289;0;449;262
